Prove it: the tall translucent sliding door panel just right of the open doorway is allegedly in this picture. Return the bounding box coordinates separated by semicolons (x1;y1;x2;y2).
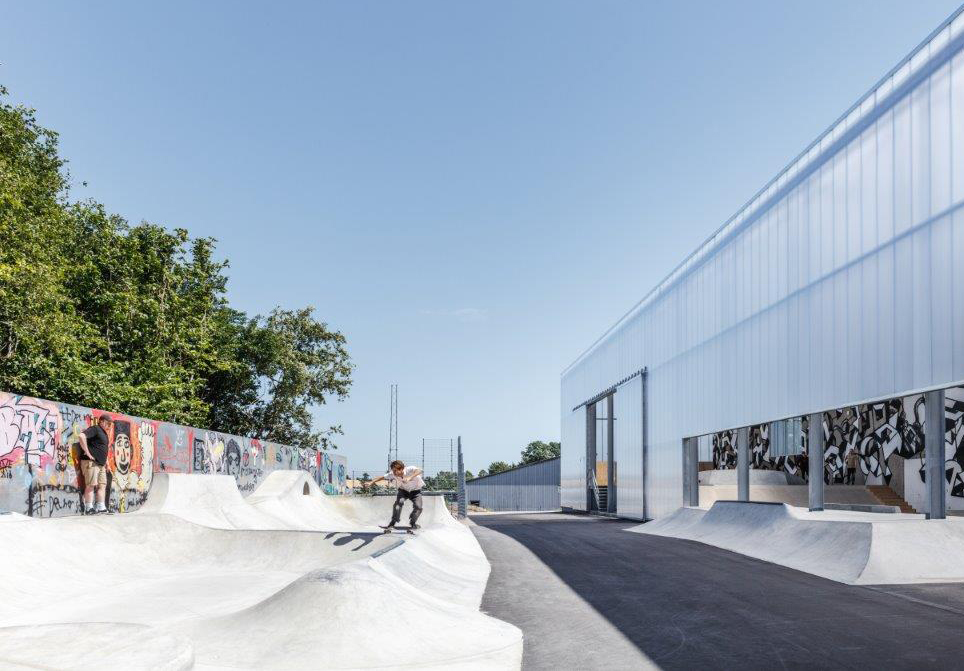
613;376;644;519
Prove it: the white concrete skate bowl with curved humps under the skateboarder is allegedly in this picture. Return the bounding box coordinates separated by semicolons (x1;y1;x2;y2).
0;471;522;669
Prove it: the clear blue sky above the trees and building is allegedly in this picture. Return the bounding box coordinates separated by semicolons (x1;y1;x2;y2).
0;0;957;471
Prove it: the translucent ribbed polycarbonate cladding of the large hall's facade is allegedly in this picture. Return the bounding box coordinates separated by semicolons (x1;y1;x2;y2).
562;13;964;517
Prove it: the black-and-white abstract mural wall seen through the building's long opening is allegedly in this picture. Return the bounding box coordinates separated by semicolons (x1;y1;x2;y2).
712;387;964;510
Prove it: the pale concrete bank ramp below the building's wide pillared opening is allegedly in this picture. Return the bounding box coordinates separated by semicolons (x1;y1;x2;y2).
630;501;964;585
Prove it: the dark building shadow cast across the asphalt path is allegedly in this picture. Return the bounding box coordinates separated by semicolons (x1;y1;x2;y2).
473;513;964;669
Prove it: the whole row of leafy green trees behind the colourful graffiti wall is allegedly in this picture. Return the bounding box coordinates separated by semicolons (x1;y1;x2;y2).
0;87;352;447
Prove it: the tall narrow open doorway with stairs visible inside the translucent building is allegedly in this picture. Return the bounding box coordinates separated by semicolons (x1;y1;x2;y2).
586;392;617;515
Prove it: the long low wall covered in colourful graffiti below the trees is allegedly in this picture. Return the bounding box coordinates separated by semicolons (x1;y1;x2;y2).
0;392;347;517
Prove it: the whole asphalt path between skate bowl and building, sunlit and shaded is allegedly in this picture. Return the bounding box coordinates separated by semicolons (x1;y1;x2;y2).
472;514;964;671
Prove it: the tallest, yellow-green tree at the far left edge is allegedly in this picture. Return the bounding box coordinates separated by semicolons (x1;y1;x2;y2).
0;87;93;398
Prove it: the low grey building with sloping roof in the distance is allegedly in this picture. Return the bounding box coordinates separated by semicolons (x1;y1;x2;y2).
465;457;559;512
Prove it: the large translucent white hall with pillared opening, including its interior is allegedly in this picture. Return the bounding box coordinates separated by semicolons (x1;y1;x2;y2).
561;10;964;519
